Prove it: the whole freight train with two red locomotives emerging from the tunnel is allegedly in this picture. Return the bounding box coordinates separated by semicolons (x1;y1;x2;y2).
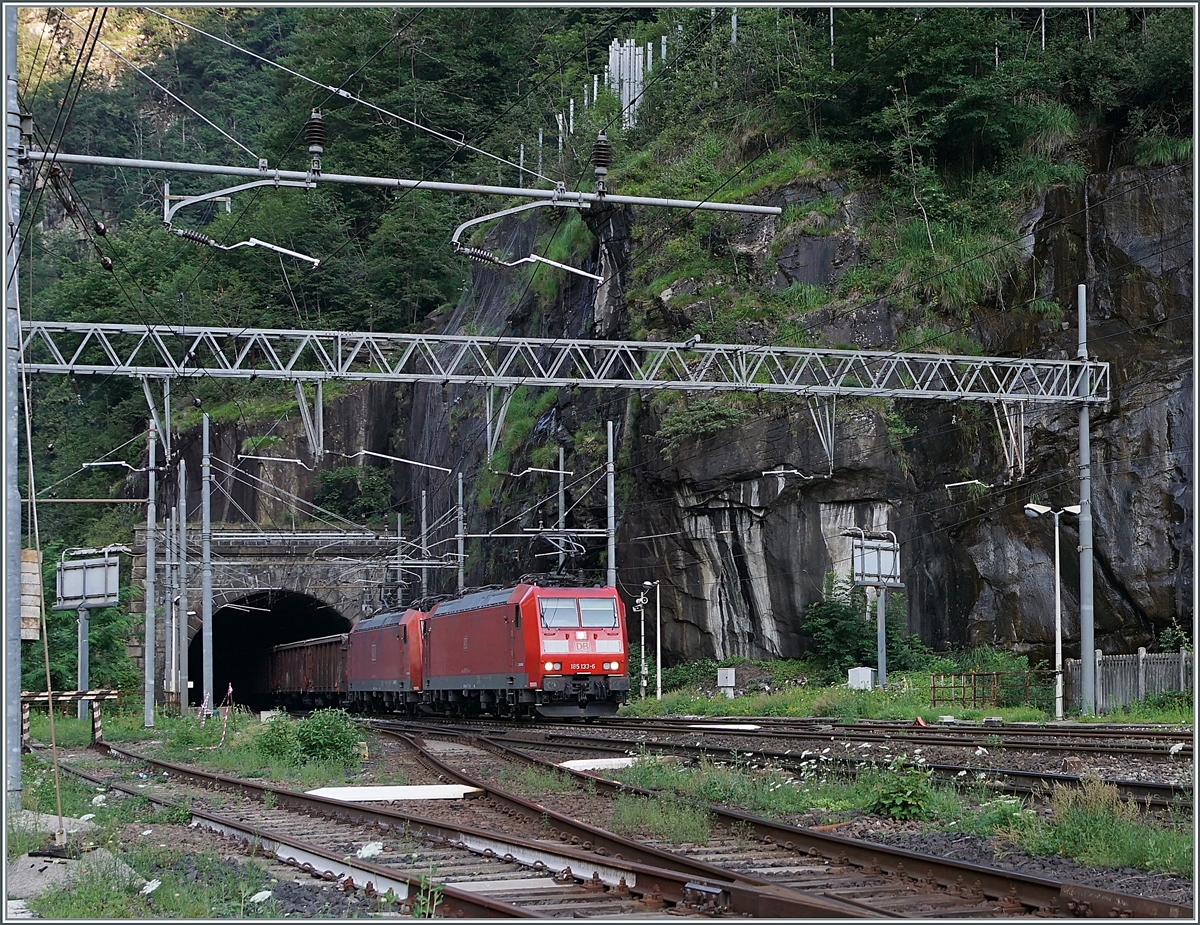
271;584;630;717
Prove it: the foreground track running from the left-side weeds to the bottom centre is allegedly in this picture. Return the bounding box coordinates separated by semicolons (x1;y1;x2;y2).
60;746;869;919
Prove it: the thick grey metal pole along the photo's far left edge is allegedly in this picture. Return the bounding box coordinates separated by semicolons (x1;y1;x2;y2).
4;5;22;811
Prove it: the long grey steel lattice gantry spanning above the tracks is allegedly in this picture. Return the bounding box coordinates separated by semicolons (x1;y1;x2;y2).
22;322;1109;404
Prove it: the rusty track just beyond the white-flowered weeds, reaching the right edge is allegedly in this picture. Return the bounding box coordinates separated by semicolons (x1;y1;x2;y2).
369;721;1193;809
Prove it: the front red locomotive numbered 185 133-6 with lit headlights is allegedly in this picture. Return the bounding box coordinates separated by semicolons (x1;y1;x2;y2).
421;584;629;717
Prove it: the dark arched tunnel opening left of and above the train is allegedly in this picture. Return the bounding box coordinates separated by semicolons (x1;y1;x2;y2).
187;591;350;710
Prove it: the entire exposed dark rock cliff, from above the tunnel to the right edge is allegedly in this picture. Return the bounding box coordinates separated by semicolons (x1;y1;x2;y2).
175;168;1194;661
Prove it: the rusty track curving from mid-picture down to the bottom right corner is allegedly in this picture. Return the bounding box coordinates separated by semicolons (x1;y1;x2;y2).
364;732;1192;918
